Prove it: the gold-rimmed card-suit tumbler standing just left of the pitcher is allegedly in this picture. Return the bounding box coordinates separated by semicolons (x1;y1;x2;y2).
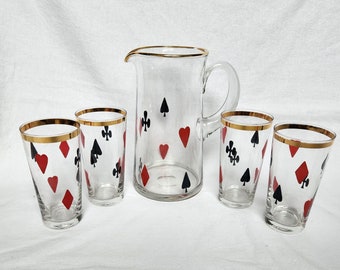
75;108;127;206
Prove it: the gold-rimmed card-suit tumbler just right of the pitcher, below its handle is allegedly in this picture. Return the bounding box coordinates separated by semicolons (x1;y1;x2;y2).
218;111;273;208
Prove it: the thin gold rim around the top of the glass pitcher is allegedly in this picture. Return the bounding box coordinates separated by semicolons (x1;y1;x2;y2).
124;45;208;62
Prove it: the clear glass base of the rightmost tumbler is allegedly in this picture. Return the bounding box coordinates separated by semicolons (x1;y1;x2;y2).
265;207;305;234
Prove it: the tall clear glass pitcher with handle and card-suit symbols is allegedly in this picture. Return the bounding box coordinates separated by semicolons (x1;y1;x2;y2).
125;46;240;201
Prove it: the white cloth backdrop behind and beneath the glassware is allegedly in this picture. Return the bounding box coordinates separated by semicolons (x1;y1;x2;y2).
0;0;340;270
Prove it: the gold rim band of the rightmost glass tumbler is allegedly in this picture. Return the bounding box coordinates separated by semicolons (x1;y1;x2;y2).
274;123;336;148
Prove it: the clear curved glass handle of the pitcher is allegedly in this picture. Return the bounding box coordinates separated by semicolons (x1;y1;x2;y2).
201;62;240;139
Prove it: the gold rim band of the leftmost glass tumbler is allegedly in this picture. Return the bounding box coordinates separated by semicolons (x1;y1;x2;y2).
19;118;79;143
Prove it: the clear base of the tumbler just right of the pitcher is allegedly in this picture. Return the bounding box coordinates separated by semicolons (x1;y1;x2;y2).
218;187;254;208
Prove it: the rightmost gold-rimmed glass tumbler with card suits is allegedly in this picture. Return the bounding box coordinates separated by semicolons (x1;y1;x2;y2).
265;123;336;233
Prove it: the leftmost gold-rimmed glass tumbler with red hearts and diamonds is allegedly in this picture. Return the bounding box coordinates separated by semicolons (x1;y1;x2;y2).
19;119;82;229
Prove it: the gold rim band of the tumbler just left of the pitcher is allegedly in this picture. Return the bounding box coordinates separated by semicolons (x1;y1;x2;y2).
75;108;126;126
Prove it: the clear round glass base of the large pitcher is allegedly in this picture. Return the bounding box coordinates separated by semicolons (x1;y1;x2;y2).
134;164;202;201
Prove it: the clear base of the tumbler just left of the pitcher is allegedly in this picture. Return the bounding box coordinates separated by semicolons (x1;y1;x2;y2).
88;185;124;206
